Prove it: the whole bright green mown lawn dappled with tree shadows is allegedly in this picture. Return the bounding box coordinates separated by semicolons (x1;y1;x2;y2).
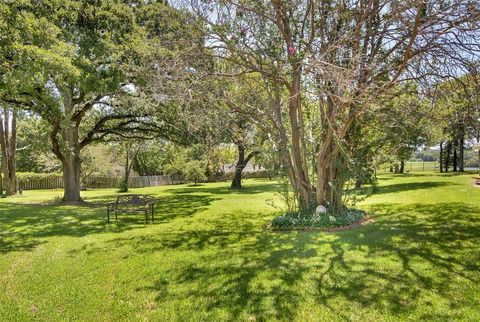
0;174;480;321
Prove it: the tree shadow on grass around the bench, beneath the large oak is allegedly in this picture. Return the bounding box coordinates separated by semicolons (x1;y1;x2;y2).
0;195;216;254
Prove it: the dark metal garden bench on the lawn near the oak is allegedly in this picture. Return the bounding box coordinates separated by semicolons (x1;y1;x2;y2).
107;195;155;224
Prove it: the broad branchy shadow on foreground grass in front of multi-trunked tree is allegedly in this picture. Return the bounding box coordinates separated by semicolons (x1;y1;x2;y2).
74;203;480;321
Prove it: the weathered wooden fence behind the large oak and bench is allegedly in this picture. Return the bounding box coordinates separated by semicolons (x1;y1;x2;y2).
18;176;185;190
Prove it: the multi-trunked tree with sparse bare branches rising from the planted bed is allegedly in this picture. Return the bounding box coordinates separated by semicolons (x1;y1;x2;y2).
190;0;479;215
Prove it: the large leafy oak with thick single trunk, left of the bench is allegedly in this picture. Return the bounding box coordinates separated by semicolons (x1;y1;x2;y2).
2;0;200;201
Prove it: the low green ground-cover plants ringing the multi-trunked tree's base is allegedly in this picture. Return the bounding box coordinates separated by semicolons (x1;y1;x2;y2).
272;208;365;230
